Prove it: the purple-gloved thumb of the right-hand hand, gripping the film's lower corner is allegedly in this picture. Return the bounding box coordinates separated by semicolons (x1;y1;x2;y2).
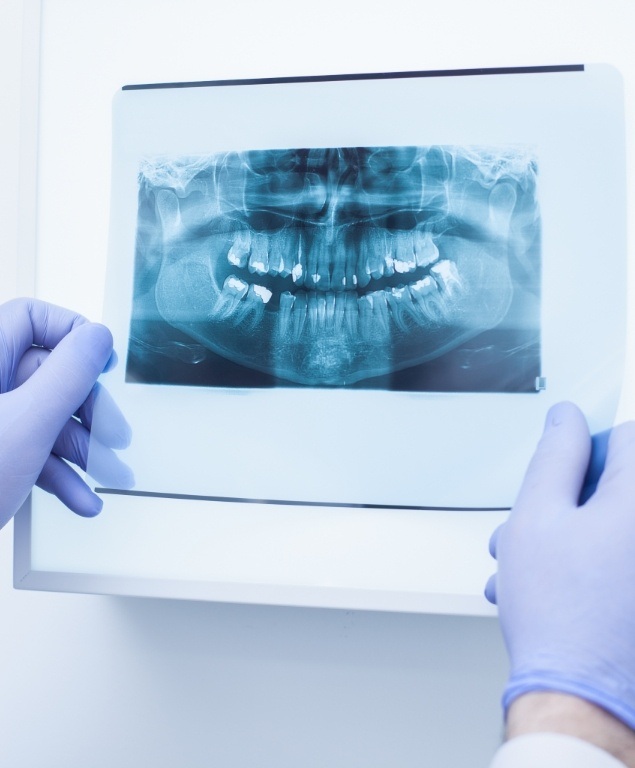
512;402;591;516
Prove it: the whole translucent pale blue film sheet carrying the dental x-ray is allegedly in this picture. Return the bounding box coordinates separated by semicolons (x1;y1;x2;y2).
89;65;627;513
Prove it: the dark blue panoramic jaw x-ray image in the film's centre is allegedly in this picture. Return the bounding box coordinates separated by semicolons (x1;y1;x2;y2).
126;145;541;392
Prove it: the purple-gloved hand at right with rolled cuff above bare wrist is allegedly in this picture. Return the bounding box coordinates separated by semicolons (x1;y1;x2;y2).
485;403;635;729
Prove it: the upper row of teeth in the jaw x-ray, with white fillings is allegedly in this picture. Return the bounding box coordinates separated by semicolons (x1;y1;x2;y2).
227;229;439;291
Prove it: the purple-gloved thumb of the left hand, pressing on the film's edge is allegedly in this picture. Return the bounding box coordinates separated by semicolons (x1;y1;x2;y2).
20;323;112;444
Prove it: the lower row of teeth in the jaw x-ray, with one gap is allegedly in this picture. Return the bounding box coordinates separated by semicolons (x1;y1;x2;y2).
211;259;460;337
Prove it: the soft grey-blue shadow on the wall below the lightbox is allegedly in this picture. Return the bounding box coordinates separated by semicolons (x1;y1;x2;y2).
112;598;507;768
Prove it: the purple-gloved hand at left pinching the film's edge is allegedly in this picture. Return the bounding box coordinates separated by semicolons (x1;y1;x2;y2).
0;299;130;526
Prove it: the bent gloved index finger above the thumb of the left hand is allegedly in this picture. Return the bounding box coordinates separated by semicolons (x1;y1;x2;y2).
0;298;88;363
